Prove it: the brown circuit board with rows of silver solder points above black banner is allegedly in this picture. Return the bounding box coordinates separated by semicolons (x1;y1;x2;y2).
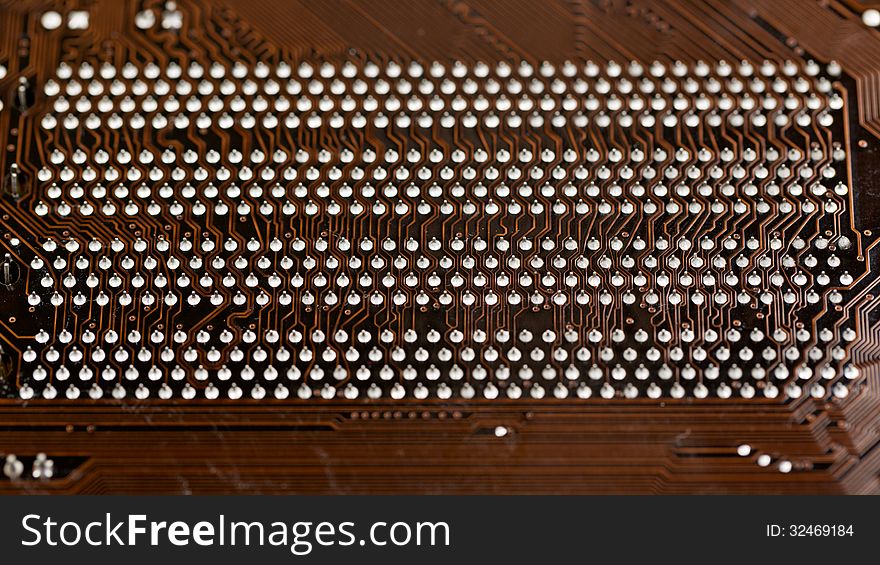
0;0;880;493
